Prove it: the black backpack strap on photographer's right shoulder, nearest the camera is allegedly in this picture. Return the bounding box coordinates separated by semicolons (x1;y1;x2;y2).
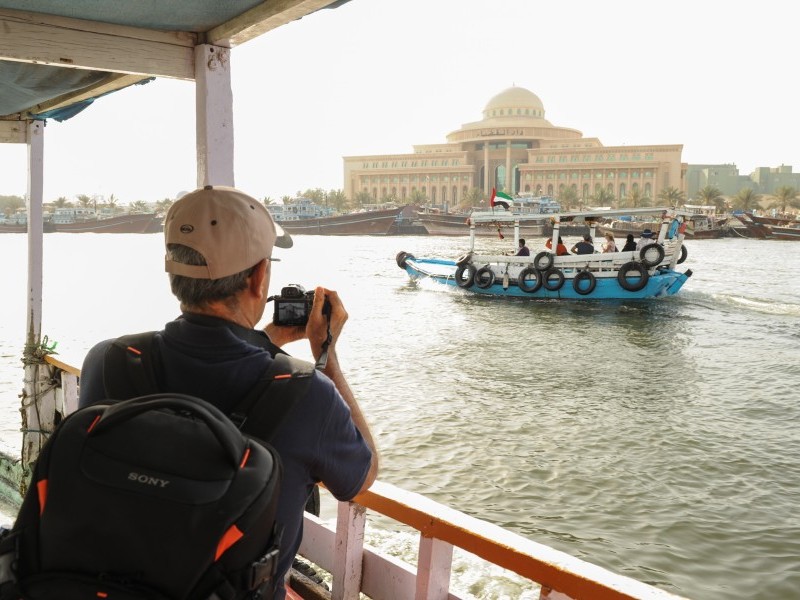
228;354;314;442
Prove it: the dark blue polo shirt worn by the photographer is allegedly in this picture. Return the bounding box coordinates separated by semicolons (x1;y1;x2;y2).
79;315;372;598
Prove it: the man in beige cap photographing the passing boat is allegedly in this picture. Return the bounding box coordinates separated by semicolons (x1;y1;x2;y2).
80;186;378;599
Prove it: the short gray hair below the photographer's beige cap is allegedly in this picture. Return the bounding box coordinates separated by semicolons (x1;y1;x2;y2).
167;244;255;308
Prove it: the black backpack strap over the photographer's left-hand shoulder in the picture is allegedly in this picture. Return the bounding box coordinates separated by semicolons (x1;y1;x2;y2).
103;331;161;400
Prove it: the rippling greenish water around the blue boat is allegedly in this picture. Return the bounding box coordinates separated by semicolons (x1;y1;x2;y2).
0;234;800;600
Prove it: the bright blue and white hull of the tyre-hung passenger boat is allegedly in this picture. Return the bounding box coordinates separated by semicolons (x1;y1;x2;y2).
403;256;692;301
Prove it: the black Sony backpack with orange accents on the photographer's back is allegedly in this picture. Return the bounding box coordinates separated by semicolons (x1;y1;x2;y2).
0;333;314;600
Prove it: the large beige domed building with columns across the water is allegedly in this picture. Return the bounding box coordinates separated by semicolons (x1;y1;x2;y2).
344;86;687;206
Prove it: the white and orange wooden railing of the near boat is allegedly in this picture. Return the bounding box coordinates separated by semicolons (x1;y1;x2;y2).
32;356;680;600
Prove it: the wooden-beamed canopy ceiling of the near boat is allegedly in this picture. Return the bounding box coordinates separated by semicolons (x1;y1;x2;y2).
0;0;349;121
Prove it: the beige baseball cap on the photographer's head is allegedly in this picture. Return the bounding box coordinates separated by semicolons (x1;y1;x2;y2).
164;185;292;279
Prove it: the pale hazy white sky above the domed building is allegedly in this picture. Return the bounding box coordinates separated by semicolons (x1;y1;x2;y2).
0;0;800;202
